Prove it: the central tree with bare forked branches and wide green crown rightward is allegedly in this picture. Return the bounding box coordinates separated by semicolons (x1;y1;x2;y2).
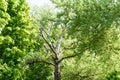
26;0;120;80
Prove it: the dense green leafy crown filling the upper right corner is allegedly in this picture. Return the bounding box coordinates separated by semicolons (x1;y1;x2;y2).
52;0;120;54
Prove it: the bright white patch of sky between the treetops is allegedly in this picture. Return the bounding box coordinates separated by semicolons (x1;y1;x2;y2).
27;0;52;6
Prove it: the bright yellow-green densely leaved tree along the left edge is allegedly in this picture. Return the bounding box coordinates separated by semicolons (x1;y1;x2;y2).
0;0;36;80
